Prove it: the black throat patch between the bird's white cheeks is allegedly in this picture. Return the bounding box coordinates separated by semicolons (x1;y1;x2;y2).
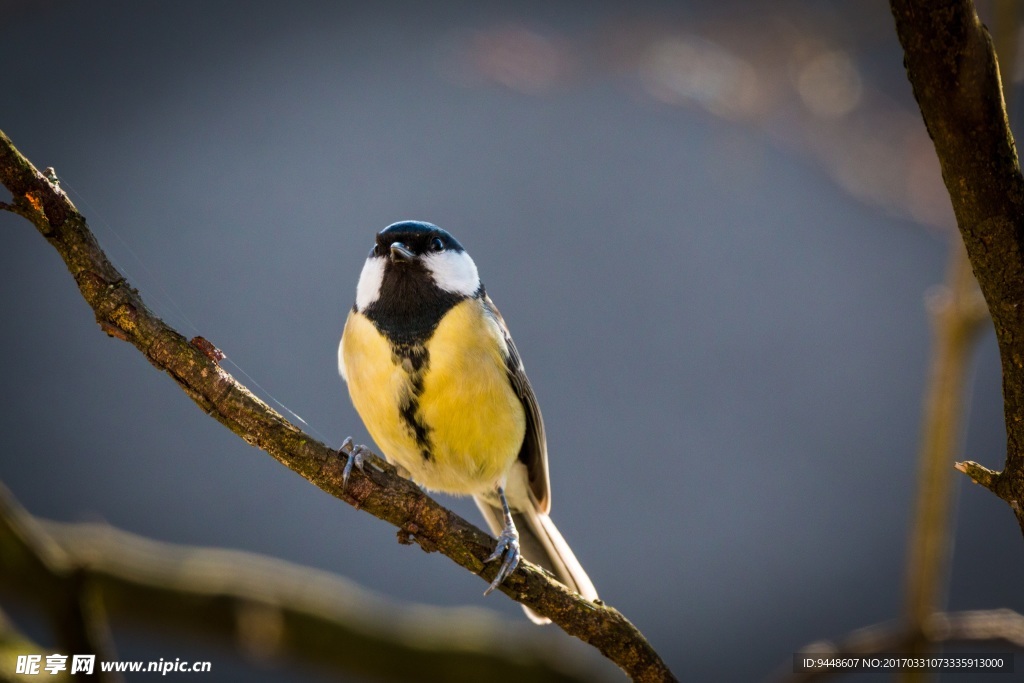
362;261;466;346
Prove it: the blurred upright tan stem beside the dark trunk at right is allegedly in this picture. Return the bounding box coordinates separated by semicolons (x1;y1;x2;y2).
901;240;988;683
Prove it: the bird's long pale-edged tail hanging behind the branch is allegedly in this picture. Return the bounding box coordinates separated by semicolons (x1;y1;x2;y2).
473;497;597;624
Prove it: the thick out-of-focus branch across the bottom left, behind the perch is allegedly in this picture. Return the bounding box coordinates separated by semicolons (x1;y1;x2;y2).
0;485;594;683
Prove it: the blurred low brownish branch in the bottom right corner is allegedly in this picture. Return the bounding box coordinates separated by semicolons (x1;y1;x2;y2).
773;609;1024;683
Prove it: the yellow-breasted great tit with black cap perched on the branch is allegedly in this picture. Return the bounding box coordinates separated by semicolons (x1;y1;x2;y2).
338;220;597;624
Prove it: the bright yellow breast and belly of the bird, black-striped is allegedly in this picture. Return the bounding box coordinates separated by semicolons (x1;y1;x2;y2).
341;299;526;495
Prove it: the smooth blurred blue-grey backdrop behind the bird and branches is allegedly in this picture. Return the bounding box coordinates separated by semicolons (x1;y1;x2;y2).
0;0;1024;681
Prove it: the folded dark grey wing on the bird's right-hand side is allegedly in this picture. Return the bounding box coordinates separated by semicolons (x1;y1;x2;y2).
483;294;551;514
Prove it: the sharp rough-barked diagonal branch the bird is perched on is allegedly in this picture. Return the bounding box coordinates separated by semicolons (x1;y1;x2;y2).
0;132;674;681
